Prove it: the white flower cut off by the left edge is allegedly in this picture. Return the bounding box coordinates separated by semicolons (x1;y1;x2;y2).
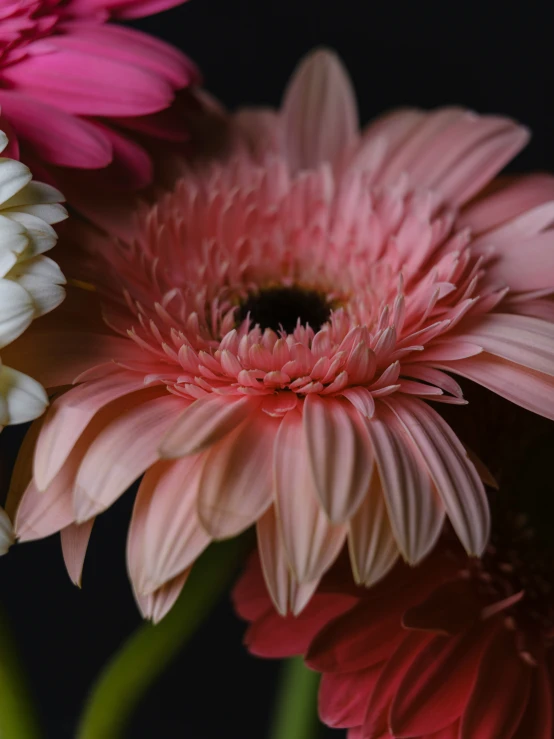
0;131;67;554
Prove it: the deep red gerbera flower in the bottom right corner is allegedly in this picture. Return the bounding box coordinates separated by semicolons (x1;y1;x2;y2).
234;446;554;739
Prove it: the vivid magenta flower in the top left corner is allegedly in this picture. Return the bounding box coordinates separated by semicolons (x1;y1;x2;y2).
0;0;198;187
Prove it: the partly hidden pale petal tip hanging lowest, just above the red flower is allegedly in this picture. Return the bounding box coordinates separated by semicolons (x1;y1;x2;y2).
256;507;319;616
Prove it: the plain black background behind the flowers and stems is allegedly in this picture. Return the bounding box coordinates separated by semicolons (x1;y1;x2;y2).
0;0;554;739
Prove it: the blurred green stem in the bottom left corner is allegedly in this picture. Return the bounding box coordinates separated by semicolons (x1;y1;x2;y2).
0;613;40;739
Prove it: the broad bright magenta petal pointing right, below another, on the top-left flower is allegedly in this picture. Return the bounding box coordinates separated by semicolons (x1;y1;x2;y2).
2;49;173;116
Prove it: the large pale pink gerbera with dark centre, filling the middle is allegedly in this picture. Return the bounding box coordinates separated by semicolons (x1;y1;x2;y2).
11;47;554;617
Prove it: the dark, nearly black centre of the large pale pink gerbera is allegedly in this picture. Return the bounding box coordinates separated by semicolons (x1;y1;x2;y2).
237;287;331;334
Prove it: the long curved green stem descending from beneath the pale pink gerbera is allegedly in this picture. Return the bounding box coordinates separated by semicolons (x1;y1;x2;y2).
77;539;244;739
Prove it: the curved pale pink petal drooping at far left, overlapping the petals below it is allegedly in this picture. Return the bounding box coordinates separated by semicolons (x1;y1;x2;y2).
33;372;144;490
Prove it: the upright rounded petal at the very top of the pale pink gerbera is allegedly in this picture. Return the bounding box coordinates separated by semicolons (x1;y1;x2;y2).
282;50;358;171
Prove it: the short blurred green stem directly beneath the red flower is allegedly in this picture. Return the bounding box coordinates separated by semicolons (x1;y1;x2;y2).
271;657;320;739
